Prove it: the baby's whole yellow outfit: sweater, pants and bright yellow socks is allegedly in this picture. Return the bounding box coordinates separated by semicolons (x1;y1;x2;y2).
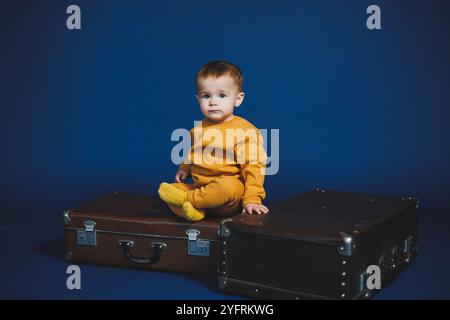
159;116;267;221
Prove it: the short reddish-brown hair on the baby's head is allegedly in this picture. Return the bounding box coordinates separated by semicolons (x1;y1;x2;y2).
195;60;244;92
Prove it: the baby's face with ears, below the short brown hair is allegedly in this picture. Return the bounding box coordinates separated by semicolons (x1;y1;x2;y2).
196;75;244;123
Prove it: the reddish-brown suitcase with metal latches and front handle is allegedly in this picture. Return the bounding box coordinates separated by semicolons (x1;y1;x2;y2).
63;193;220;274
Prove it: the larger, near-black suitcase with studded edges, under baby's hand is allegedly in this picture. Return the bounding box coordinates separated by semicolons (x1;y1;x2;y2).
218;189;418;299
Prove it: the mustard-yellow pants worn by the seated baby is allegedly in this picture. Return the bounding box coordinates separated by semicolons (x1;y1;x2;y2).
168;176;244;217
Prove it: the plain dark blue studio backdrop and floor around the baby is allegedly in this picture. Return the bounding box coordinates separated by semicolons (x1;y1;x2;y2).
0;0;450;299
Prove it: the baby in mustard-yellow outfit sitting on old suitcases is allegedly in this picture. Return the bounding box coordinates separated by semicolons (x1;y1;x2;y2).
158;61;269;221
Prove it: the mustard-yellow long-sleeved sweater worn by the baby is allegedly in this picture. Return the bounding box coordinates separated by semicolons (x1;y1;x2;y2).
180;116;267;206
